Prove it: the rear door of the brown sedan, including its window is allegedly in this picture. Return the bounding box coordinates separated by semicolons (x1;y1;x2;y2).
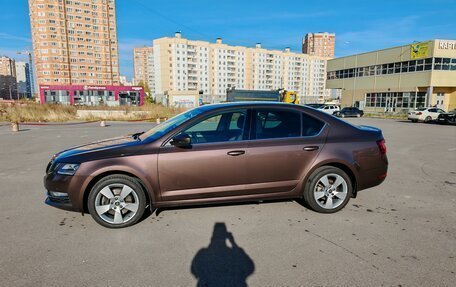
242;108;326;194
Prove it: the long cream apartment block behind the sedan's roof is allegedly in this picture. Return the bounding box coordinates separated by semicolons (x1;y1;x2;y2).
153;33;326;103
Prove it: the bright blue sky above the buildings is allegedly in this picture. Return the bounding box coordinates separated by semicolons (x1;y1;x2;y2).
0;0;456;77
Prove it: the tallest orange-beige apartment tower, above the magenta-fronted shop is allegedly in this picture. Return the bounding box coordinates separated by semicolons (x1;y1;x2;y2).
29;0;119;85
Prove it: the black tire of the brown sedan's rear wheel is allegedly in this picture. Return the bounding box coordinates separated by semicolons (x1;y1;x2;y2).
303;166;353;213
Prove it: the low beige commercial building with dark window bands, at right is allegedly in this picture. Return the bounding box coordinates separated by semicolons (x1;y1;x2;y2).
327;40;456;112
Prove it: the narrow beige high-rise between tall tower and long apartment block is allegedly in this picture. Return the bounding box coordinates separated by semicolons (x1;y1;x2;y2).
133;47;155;91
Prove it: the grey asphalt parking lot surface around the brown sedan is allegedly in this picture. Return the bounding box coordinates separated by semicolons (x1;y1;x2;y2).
0;118;456;286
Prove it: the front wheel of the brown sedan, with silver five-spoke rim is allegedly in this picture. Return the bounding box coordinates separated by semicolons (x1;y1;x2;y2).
87;174;147;228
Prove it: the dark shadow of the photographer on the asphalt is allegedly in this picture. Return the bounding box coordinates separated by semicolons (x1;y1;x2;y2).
191;222;255;287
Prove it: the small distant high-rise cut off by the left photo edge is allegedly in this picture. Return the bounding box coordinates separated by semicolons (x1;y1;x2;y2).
0;57;17;100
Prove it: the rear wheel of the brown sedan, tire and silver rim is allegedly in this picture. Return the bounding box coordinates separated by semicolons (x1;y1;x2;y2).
304;166;353;213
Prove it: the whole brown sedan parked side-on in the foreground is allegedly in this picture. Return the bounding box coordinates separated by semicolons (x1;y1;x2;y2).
44;102;388;228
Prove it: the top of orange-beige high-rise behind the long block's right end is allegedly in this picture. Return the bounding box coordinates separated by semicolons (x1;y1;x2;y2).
302;32;336;58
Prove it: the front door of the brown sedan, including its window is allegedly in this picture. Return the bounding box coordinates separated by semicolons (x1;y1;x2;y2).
158;109;249;201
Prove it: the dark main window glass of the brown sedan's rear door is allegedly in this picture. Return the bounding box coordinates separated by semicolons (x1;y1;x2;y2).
253;109;301;139
